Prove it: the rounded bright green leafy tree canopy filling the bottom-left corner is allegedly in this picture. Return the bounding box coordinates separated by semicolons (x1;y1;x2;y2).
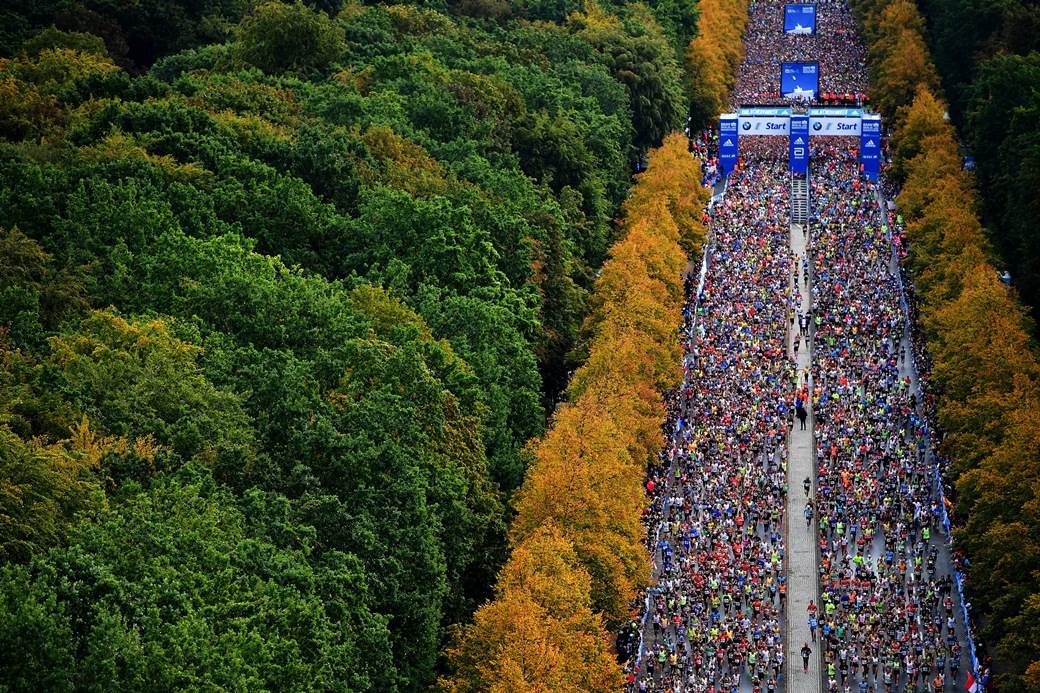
0;469;393;691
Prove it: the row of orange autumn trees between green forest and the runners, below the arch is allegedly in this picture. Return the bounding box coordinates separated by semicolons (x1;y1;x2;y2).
440;133;707;693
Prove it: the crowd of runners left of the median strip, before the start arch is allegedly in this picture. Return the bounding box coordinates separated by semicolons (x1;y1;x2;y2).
630;138;794;692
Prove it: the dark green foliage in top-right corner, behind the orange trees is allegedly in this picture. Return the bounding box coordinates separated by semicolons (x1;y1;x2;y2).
921;0;1040;317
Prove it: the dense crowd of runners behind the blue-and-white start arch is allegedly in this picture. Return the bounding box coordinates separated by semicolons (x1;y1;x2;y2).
732;0;869;108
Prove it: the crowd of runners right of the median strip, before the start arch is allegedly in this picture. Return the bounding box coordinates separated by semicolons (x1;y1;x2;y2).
802;140;962;692
